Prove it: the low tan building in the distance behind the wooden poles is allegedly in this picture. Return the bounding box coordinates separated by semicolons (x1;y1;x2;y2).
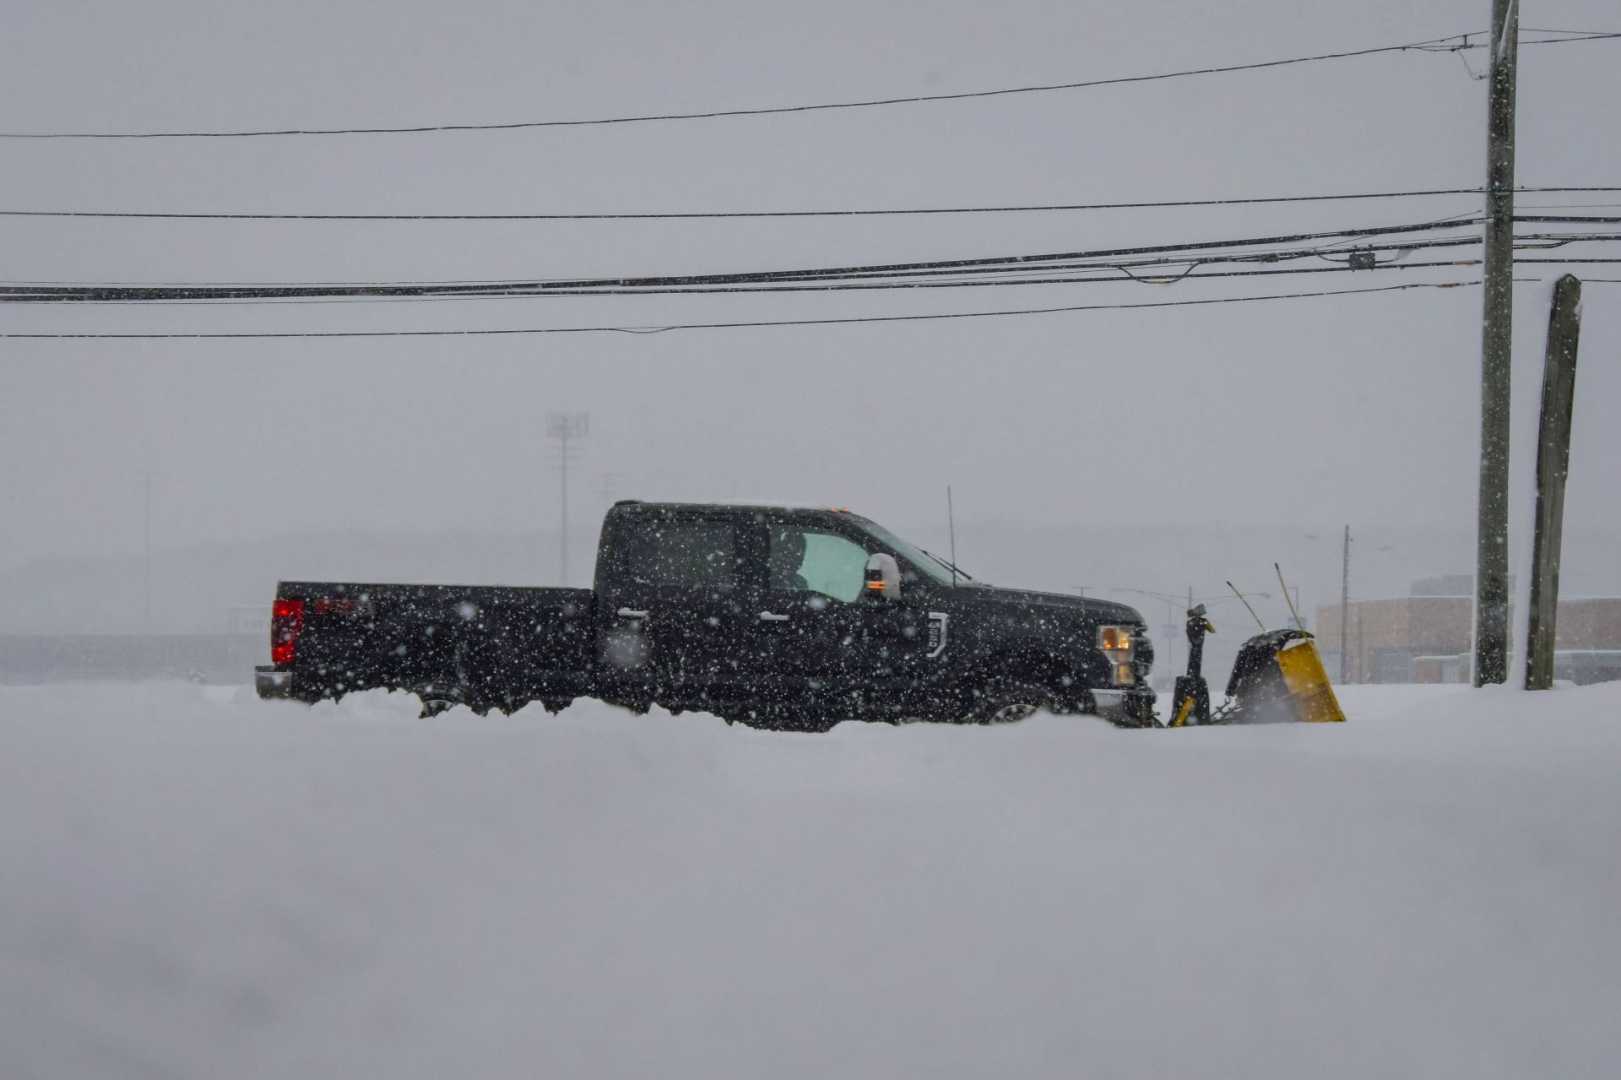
1316;574;1621;684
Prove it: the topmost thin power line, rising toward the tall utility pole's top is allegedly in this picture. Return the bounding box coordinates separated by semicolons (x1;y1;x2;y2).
0;32;1621;139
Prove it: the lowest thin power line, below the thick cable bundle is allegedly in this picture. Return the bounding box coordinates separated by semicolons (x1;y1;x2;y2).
0;277;1480;341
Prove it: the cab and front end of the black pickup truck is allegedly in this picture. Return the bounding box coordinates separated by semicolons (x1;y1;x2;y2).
595;501;1153;728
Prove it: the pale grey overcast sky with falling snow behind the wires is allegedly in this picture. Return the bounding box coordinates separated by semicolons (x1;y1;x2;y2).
0;0;1621;580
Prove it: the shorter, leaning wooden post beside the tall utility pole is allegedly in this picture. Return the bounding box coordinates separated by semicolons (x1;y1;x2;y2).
1525;274;1582;689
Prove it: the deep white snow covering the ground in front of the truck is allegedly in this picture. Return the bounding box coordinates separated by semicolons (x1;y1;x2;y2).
0;684;1621;1080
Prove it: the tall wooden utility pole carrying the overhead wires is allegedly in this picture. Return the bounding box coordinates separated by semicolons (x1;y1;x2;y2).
1473;0;1519;686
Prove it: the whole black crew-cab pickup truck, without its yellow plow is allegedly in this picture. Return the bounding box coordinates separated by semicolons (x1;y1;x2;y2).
254;501;1154;731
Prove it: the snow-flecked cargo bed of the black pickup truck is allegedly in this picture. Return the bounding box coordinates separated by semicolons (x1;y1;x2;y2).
274;581;595;709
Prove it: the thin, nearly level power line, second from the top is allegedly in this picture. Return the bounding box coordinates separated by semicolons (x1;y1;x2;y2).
0;186;1621;222
